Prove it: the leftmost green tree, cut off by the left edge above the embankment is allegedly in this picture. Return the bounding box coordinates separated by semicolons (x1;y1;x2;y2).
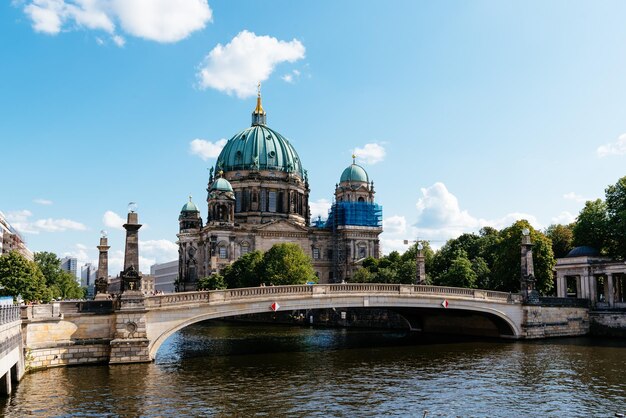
0;251;52;302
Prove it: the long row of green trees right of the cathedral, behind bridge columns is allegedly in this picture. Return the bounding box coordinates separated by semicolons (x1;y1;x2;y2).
350;177;626;295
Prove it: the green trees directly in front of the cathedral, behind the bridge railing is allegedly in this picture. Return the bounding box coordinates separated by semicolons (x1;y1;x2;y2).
198;243;317;290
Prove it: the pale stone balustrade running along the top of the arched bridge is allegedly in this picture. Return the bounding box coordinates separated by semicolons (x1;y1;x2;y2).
145;283;519;308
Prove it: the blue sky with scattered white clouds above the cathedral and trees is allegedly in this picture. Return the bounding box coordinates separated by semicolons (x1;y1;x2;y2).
0;0;626;275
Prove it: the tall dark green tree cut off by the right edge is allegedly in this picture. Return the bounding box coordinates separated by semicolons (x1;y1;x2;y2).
605;176;626;260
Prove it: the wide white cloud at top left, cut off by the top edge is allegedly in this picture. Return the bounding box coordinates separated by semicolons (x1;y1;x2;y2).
24;0;212;46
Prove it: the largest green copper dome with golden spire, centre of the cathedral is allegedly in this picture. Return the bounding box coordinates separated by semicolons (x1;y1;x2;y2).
216;95;304;179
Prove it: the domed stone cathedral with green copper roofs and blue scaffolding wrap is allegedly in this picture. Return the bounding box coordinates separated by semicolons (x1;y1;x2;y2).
177;92;382;291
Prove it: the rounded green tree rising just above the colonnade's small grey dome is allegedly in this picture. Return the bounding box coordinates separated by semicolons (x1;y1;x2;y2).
572;199;609;252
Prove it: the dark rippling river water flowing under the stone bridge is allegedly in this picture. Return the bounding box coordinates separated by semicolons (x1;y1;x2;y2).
0;321;626;417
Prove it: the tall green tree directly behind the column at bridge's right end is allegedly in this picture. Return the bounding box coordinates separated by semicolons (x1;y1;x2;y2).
491;220;555;294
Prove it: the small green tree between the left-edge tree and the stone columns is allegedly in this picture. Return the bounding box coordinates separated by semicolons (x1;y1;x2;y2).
35;251;85;299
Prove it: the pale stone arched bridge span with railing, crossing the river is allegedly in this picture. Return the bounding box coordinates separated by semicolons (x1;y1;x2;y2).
146;284;522;359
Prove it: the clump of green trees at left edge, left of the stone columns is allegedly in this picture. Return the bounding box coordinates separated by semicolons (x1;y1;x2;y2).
0;251;86;302
